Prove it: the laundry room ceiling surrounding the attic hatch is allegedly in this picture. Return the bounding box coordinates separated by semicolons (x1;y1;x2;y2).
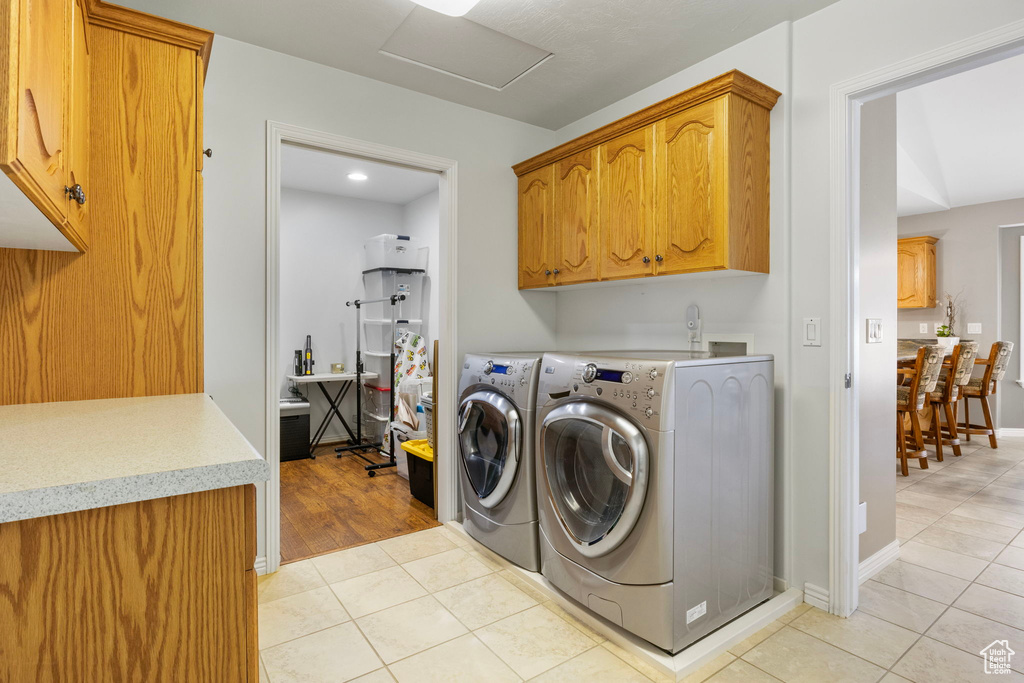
112;0;836;129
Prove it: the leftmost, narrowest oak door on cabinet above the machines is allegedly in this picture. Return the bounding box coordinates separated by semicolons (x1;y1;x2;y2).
519;166;555;289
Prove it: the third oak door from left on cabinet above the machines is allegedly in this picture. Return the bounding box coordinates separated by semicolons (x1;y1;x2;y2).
598;125;654;280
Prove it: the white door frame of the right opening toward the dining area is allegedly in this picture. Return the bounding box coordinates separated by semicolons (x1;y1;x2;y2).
828;17;1024;616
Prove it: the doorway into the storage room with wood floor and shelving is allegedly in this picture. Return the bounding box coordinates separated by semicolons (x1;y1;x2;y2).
266;123;456;571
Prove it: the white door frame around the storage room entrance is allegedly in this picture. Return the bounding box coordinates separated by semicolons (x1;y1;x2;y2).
264;121;459;572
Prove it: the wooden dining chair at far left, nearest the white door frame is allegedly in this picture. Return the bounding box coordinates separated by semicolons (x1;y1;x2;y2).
896;344;944;476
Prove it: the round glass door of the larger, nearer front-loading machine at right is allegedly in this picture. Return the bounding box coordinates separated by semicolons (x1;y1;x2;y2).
541;401;649;557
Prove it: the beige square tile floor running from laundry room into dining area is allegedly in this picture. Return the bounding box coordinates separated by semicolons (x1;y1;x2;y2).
259;438;1024;683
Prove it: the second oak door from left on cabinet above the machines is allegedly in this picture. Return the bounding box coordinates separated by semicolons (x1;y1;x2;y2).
554;147;600;285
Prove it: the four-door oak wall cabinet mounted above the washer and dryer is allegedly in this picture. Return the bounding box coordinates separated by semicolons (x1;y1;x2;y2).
513;71;779;289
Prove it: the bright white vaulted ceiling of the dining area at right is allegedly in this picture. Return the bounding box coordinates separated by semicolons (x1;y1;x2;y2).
896;55;1024;216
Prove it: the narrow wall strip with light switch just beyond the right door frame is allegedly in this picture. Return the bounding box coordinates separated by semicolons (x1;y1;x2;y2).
856;95;896;561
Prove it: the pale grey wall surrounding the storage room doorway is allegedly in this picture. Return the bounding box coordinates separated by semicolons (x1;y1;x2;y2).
203;36;555;555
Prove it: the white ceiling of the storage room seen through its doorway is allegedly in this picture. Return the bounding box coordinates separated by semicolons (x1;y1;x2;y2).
281;144;438;205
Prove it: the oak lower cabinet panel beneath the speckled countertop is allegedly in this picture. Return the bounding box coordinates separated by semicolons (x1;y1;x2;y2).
0;484;259;683
